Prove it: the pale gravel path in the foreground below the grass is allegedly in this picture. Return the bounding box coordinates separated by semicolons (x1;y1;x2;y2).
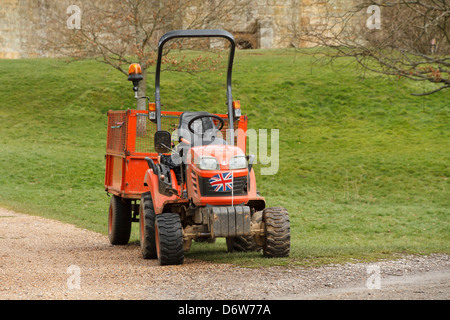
0;209;450;300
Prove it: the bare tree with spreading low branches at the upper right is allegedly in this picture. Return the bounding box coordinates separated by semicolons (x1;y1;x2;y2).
298;0;450;96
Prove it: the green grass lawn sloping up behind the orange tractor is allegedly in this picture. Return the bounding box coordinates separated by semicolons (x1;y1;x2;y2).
0;50;450;266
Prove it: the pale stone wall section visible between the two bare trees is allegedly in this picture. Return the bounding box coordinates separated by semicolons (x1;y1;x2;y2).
183;0;355;49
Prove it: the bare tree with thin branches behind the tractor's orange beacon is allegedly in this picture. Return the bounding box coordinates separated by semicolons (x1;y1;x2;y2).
41;0;248;109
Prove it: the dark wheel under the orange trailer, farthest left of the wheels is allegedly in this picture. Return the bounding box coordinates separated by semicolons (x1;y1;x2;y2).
108;195;131;245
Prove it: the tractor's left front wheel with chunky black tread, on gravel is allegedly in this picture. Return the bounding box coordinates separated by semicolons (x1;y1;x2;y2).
155;212;184;266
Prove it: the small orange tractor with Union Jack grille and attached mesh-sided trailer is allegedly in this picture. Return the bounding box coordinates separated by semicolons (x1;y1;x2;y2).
105;30;290;265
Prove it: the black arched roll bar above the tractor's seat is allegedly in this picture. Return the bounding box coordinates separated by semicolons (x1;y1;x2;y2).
155;29;236;141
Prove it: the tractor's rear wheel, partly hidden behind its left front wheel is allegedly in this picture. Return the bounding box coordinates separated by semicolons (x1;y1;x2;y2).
139;192;157;259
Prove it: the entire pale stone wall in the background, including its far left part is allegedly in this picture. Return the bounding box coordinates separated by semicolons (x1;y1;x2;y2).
0;0;353;59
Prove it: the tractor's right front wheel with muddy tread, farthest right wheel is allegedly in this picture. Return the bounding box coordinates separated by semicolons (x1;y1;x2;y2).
263;207;291;257
